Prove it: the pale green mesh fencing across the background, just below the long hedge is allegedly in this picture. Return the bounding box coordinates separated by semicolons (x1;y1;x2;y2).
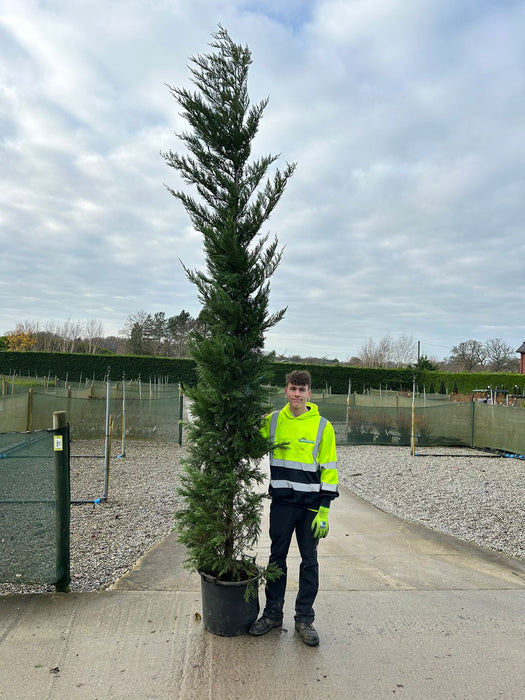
0;379;525;454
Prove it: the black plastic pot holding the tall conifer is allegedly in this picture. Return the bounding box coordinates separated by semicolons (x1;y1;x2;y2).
200;571;260;637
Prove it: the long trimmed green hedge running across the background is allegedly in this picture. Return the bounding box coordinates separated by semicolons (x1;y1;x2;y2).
0;351;525;394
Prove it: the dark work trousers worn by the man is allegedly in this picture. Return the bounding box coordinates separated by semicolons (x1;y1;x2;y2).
264;501;319;623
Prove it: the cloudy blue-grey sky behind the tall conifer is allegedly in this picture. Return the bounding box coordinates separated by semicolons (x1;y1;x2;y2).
0;0;525;360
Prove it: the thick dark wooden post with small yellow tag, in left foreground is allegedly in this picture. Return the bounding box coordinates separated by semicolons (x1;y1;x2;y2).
53;411;71;593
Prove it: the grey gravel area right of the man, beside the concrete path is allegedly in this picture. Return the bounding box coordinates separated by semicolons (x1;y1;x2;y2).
334;445;525;560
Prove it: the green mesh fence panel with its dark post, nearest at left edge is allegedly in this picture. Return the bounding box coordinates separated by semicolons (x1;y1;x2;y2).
0;428;70;586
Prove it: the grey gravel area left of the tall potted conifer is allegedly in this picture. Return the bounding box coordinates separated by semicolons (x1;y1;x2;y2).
0;440;184;594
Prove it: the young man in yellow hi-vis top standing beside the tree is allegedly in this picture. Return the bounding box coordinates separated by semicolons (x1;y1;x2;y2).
249;370;338;646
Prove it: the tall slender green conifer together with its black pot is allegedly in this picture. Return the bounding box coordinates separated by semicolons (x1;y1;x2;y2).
162;27;295;636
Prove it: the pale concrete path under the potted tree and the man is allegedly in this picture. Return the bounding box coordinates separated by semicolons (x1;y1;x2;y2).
0;490;525;700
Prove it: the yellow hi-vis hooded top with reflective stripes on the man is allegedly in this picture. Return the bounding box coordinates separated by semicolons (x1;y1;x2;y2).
261;403;339;510
